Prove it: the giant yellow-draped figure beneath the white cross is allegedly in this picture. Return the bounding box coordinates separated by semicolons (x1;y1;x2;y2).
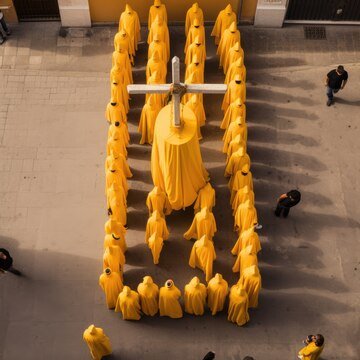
151;104;209;210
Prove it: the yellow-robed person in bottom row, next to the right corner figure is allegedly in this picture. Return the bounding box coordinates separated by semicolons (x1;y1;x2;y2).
207;273;229;316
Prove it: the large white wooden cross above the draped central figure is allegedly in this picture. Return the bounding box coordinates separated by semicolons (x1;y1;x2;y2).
127;56;227;127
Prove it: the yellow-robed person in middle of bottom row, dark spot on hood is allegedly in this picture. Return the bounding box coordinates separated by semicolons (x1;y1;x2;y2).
159;280;183;319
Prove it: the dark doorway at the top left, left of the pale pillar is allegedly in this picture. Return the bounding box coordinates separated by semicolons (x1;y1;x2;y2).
14;0;60;21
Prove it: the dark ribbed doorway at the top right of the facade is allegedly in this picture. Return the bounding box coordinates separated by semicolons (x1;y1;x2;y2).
286;0;360;21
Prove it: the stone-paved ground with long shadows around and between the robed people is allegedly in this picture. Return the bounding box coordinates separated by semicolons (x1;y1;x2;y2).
0;23;360;360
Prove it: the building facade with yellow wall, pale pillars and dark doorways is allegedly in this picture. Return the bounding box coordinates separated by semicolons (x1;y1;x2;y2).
0;0;360;27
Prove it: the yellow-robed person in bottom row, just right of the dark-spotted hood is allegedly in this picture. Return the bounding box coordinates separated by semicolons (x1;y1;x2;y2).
184;276;206;315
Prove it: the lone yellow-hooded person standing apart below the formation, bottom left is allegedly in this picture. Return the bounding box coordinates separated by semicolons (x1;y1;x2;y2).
83;325;111;360
